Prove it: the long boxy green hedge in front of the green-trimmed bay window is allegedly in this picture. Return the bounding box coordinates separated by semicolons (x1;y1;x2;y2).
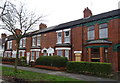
67;61;112;75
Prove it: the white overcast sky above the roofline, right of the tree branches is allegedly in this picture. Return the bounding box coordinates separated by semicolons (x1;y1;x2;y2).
0;0;120;34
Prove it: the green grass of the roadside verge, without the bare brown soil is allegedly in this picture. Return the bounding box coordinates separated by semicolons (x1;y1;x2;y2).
0;66;93;83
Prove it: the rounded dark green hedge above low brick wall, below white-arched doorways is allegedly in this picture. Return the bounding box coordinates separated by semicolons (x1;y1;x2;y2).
35;56;68;67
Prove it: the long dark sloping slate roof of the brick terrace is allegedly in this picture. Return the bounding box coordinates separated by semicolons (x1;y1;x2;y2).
33;9;120;35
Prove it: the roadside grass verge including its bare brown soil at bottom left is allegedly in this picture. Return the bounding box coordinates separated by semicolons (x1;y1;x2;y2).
0;66;94;83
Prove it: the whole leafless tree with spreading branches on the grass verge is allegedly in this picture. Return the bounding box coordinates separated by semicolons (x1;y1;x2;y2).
0;1;43;72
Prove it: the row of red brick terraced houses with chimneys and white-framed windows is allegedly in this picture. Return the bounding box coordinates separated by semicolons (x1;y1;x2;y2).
1;8;120;71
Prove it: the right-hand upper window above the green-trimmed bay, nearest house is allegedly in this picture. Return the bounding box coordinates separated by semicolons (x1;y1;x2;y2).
99;24;108;38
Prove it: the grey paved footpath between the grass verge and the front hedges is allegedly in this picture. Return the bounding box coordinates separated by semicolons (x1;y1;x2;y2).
0;64;120;83
